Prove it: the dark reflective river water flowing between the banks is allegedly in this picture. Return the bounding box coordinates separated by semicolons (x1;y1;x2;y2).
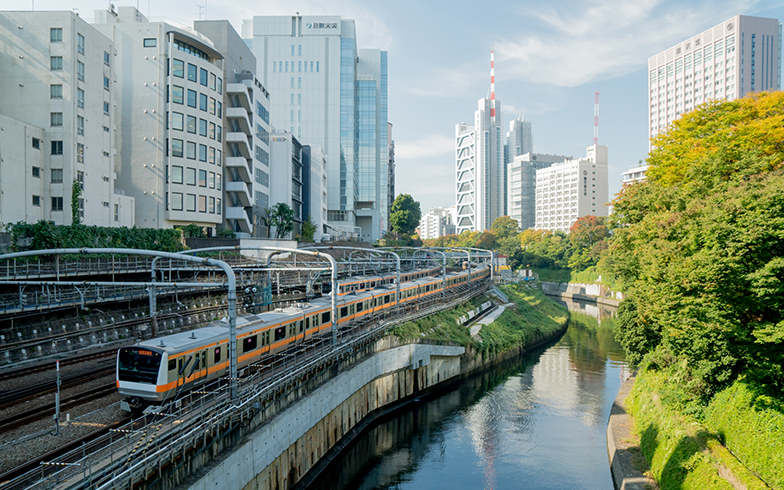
309;302;629;490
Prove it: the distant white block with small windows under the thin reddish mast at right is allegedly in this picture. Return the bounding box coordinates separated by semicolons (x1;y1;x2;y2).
535;145;608;232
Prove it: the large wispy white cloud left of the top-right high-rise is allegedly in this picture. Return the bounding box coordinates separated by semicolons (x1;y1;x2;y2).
495;0;757;87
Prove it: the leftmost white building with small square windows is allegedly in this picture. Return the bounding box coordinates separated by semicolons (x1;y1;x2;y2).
0;11;134;226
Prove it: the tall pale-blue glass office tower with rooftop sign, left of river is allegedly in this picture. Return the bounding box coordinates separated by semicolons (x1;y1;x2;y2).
242;15;388;241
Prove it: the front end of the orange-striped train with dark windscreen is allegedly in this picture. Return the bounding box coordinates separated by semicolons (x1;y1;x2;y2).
117;345;168;412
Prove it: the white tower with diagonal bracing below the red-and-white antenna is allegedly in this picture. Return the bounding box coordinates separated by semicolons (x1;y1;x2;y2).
455;98;505;235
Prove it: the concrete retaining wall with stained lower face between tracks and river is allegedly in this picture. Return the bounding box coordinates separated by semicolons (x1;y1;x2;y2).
190;341;465;490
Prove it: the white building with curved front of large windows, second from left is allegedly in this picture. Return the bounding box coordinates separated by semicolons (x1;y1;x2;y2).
94;7;227;233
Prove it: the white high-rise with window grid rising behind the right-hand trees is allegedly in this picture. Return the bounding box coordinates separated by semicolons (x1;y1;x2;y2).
648;15;781;142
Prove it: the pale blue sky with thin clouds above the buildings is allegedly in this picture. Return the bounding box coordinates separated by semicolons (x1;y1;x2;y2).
10;0;784;213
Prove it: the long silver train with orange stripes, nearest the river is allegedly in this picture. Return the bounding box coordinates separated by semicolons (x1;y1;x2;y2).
116;264;490;411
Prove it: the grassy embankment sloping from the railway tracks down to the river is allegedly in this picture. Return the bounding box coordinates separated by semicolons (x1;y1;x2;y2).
391;283;568;355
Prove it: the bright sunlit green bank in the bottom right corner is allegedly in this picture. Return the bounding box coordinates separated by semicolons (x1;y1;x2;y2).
627;364;784;490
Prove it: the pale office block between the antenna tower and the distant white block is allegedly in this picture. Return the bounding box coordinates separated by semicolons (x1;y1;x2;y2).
506;153;571;230
